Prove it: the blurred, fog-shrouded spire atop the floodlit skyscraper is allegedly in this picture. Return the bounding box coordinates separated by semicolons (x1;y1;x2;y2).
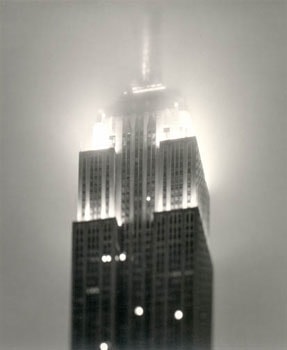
141;6;160;85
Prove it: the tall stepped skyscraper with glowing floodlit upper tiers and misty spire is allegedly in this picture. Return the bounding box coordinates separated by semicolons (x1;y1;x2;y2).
72;8;212;350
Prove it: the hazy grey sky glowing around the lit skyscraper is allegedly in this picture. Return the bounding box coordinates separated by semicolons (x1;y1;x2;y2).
0;0;287;350
